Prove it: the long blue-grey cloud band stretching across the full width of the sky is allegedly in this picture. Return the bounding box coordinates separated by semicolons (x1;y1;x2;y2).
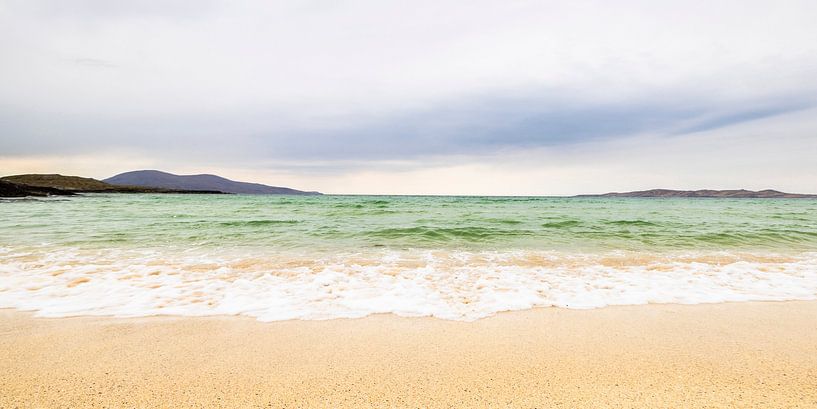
0;87;808;168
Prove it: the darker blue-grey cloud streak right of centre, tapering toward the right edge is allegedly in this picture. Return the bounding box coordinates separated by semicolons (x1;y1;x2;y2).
261;98;813;160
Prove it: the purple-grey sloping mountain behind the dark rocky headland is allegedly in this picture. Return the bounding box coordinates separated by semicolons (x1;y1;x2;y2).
104;170;320;195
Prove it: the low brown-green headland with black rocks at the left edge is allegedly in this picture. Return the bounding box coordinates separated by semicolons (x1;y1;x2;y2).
0;174;222;197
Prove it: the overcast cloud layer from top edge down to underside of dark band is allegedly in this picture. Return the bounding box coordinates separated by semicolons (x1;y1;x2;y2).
0;0;817;181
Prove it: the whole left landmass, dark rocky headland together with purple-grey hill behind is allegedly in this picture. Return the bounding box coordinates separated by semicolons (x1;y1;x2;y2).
0;170;320;197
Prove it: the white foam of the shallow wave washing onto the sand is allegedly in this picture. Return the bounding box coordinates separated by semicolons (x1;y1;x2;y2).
0;248;817;321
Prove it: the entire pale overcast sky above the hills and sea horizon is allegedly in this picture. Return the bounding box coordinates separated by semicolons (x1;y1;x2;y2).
0;0;817;195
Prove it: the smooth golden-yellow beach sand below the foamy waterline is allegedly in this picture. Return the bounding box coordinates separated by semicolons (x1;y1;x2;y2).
0;302;817;408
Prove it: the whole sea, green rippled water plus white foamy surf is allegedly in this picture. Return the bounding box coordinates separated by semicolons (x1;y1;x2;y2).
0;194;817;321
